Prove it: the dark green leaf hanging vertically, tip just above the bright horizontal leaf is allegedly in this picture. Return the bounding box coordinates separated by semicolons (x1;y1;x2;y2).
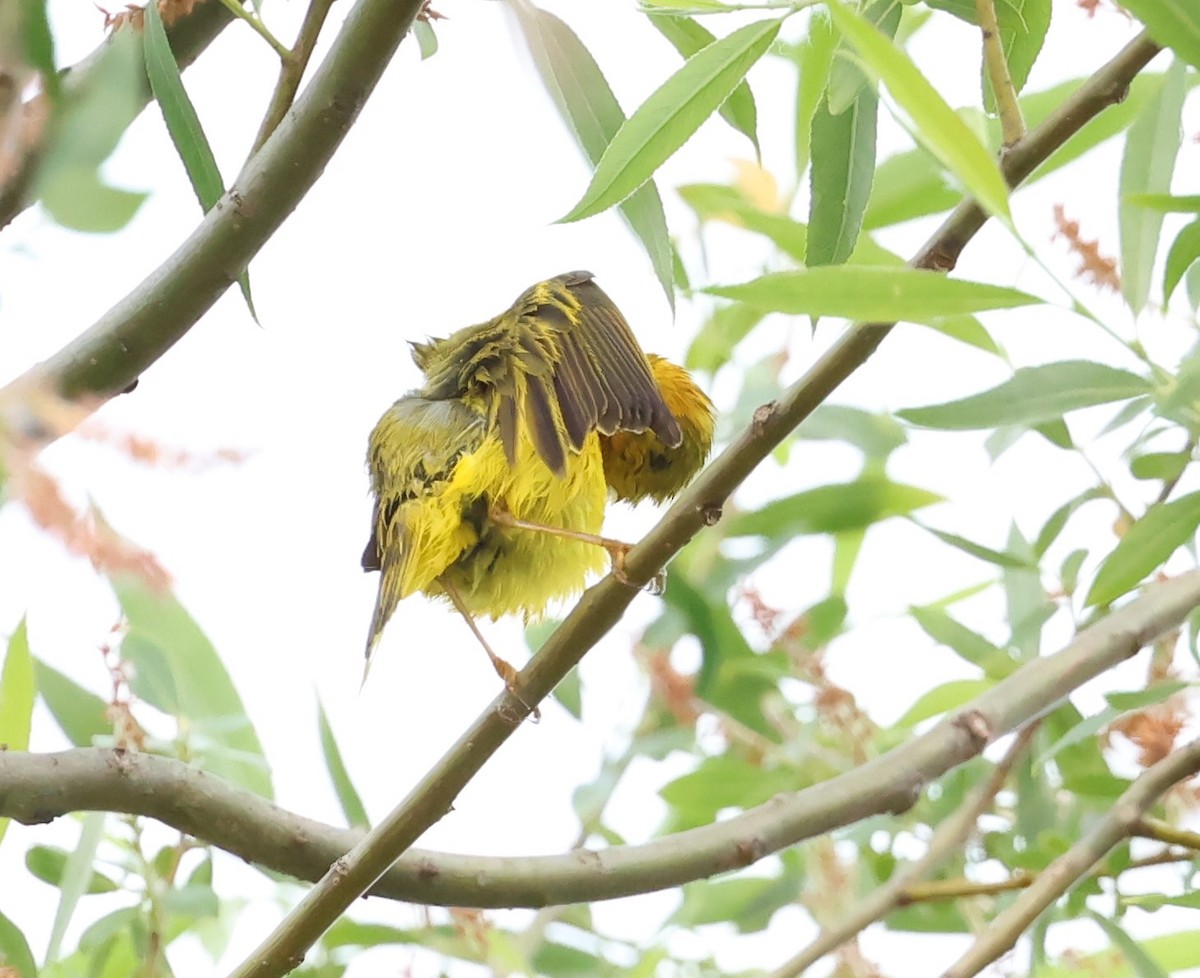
805;85;880;266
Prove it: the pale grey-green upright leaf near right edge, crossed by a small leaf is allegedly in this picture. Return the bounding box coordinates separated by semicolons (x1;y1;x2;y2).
1117;61;1187;313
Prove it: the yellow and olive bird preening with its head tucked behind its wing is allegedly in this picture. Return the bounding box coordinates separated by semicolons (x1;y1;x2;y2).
362;271;714;690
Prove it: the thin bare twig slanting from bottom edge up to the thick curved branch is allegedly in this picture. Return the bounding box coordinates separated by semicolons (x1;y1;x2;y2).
769;721;1038;978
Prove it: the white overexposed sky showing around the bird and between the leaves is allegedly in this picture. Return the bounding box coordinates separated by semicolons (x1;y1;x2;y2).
0;0;1200;978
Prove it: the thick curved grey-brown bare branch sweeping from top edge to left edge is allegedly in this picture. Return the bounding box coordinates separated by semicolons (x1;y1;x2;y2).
2;0;421;397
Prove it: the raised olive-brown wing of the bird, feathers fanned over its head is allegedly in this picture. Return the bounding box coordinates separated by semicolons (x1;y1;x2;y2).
414;271;682;474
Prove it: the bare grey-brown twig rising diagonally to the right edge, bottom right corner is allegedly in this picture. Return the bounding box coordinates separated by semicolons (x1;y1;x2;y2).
943;739;1200;978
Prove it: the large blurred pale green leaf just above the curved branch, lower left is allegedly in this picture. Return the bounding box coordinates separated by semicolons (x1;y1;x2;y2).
113;577;272;798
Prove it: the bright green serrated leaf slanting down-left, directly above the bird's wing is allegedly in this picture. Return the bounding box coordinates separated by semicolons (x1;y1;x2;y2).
560;20;780;222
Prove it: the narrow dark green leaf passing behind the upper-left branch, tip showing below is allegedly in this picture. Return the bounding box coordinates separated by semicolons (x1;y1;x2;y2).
142;4;258;323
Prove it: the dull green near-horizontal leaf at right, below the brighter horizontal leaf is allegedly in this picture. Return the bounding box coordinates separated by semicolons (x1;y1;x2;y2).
896;360;1151;431
